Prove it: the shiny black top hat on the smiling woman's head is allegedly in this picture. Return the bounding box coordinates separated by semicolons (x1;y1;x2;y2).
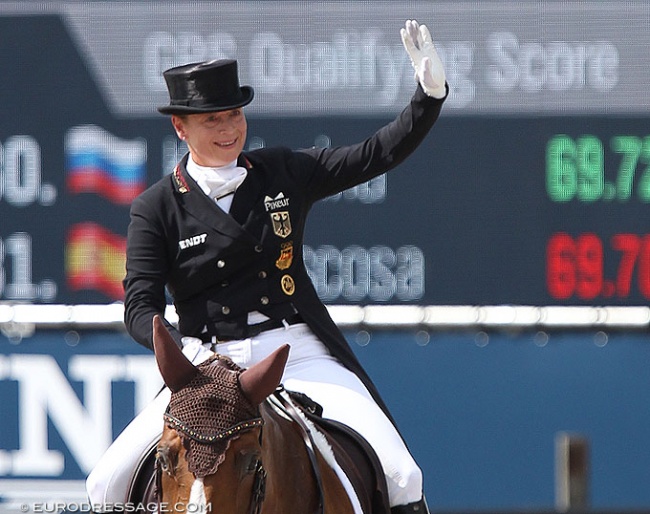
158;59;254;114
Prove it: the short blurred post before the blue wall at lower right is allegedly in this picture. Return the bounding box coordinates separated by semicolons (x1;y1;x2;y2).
555;432;589;512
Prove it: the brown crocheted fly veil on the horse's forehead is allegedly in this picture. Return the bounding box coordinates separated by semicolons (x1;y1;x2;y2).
165;355;262;477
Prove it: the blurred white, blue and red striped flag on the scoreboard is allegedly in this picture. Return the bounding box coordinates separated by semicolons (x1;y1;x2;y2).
65;125;147;205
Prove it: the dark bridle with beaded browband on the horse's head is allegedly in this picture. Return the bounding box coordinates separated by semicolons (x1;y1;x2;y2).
156;412;266;514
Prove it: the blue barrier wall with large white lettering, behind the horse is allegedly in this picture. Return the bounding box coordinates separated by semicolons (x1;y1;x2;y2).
0;330;650;510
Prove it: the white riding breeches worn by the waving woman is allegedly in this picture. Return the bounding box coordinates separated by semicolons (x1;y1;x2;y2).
87;324;422;506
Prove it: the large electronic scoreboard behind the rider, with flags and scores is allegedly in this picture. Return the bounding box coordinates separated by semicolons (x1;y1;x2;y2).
0;1;650;306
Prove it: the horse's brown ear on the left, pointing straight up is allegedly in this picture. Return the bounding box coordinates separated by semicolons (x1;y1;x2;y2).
153;314;198;393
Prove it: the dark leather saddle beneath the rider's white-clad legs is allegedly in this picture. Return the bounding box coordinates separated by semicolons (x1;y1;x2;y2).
129;389;390;514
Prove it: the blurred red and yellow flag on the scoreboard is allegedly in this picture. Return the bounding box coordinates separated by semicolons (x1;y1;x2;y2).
65;222;126;300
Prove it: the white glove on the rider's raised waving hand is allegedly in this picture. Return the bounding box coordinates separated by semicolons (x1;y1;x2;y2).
400;20;446;99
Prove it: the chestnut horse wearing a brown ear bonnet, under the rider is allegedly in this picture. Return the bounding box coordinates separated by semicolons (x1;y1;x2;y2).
131;316;390;514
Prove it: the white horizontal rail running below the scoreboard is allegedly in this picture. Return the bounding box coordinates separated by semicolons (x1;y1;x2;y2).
0;303;650;337
